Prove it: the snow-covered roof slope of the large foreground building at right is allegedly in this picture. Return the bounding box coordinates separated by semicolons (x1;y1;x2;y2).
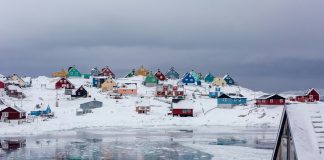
286;104;324;160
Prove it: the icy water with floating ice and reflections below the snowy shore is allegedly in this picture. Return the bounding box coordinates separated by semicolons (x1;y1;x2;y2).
0;126;276;160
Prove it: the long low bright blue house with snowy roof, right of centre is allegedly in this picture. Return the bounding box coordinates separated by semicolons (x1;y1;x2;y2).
217;94;247;108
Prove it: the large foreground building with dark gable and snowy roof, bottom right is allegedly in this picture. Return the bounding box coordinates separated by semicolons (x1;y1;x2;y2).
272;104;324;160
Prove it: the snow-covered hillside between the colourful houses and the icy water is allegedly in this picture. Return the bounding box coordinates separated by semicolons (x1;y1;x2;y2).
0;77;296;135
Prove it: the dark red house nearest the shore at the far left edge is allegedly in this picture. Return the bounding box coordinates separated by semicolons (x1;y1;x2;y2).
0;107;26;123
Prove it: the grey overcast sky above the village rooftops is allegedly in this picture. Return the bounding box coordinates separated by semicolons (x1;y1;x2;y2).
0;0;324;92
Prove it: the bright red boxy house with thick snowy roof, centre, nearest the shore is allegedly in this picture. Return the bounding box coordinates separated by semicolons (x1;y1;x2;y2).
171;101;194;117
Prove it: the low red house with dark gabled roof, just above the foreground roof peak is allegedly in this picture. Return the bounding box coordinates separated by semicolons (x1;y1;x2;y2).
255;94;286;106
